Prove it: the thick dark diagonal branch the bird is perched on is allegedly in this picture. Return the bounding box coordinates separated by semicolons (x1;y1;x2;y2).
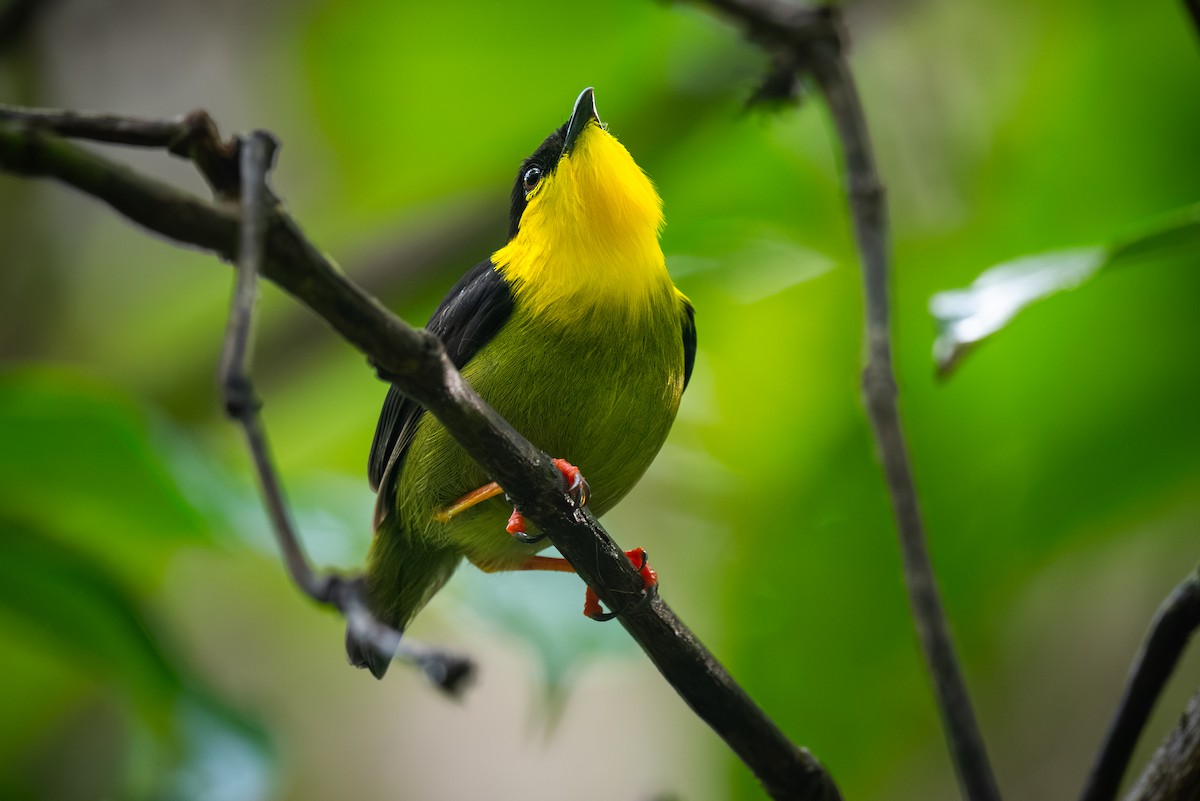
0;109;841;801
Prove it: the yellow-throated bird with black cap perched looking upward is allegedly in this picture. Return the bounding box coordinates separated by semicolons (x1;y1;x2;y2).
346;88;696;679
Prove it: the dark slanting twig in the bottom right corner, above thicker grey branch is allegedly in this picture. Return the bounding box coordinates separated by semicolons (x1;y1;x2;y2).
1079;567;1200;801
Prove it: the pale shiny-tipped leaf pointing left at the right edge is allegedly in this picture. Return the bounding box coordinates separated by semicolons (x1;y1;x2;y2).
929;200;1200;378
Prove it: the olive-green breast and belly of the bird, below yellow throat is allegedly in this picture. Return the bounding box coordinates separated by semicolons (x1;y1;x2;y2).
397;284;684;567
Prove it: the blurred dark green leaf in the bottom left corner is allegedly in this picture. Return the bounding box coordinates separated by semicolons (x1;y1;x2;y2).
0;520;275;801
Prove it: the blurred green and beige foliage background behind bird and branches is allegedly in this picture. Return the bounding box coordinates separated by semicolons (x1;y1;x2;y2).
0;0;1200;801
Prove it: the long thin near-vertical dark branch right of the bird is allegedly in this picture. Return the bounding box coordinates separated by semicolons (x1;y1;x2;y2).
686;0;1000;801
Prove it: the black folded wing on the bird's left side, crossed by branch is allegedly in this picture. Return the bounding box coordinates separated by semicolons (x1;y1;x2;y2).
367;259;512;503
